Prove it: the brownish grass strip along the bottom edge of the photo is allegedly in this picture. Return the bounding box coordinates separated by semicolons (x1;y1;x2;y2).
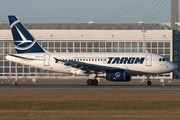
0;110;180;120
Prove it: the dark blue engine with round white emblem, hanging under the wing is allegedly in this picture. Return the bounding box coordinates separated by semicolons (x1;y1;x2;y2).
106;69;131;82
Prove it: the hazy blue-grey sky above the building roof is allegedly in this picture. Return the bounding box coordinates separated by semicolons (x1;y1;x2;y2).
0;0;177;23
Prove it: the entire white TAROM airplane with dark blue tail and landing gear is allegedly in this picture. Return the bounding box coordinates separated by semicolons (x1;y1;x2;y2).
5;15;177;85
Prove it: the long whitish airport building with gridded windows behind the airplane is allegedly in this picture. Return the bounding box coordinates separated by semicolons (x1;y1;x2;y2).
0;23;180;79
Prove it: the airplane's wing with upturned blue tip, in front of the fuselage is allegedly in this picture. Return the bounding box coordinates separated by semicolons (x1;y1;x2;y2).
60;60;120;73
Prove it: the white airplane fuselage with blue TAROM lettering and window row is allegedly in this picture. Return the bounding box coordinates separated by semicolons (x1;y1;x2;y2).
6;52;177;75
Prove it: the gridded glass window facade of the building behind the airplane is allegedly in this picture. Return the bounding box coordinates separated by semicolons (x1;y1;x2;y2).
0;40;171;78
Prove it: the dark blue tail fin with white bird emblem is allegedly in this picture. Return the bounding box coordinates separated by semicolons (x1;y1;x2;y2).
8;15;45;54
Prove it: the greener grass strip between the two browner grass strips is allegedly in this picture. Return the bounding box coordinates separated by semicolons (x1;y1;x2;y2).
0;100;180;111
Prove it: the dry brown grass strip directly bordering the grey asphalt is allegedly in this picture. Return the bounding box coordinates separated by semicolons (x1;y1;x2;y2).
0;90;180;101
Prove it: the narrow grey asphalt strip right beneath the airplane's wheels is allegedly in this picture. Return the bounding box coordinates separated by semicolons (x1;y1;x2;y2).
0;84;180;90
